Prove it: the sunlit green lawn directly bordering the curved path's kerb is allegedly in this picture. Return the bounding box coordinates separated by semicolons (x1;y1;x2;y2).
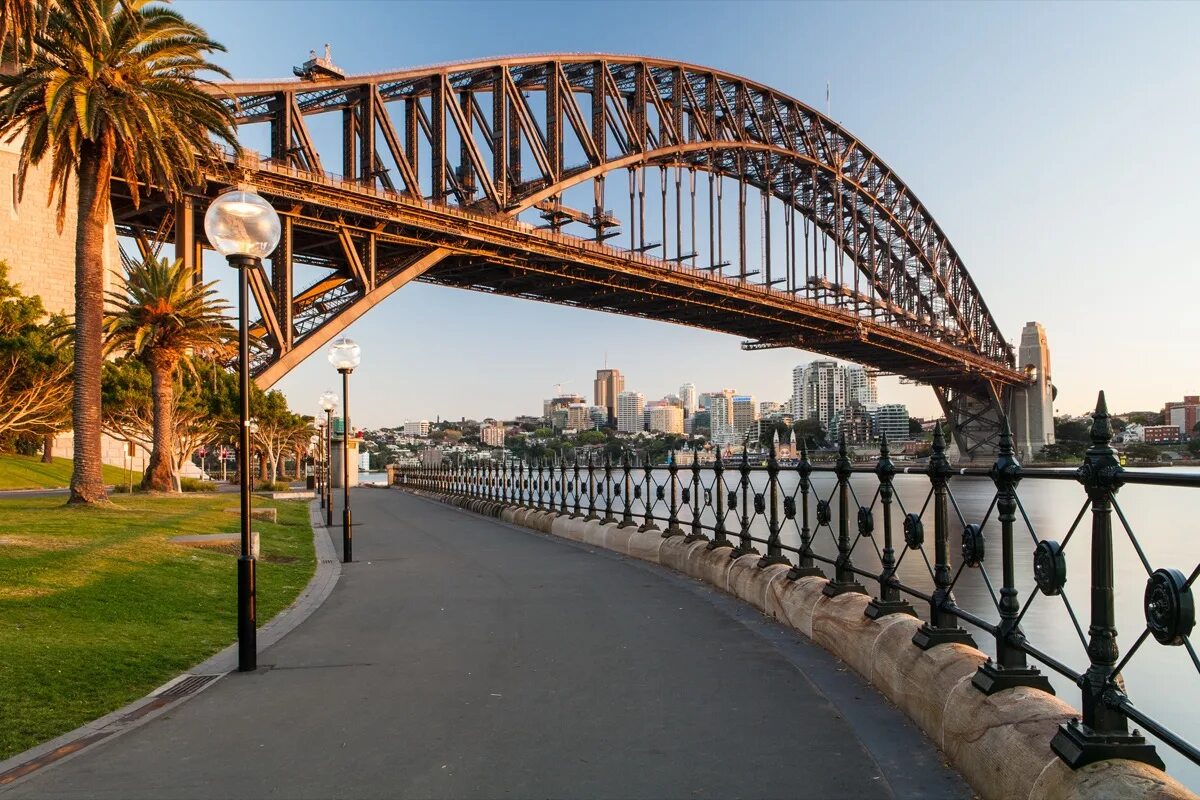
0;495;316;759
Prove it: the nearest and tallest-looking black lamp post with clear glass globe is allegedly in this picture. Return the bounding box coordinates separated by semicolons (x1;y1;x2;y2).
204;191;280;672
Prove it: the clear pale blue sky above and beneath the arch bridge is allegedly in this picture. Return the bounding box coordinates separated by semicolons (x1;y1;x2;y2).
175;0;1200;427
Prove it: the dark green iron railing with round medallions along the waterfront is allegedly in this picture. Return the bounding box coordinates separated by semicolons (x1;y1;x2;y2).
395;392;1200;768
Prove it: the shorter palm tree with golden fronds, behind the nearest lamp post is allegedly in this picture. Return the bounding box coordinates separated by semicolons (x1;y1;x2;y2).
104;258;236;492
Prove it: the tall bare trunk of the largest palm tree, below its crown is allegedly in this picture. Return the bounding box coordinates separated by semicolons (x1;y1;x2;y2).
68;142;113;504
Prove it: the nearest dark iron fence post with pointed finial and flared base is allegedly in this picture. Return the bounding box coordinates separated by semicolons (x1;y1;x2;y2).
1050;391;1165;769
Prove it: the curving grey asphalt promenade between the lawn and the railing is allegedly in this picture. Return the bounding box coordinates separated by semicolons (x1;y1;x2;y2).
0;489;971;799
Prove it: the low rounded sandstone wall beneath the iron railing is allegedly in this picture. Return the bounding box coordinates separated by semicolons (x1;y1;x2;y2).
406;489;1200;800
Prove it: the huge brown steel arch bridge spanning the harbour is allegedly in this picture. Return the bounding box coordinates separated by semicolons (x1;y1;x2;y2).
114;54;1026;457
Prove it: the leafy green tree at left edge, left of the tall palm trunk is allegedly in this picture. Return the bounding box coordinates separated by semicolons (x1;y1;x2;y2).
0;261;71;450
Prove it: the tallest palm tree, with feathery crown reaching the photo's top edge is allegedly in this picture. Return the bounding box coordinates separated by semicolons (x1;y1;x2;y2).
0;0;238;503
